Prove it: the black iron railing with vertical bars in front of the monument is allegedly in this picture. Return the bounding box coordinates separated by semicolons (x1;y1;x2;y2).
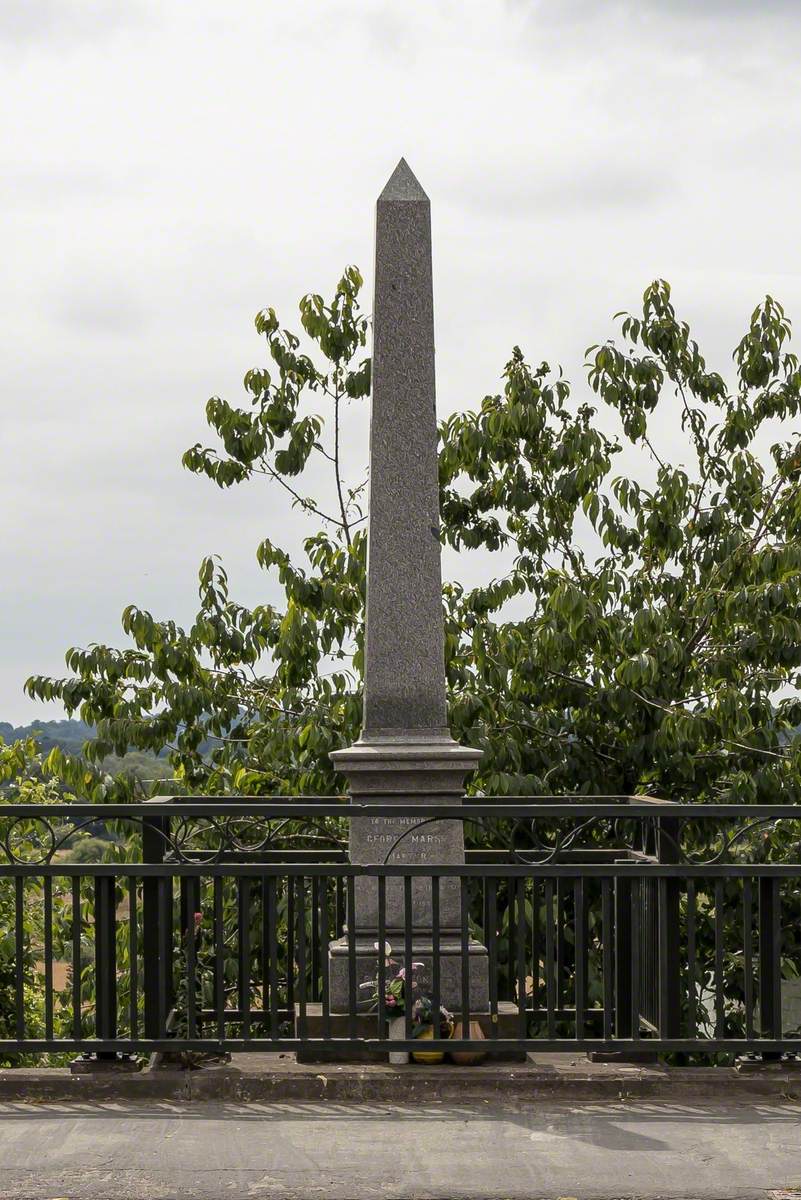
0;797;801;1055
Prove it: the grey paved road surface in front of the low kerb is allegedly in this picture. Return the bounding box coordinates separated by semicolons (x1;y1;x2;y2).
0;1100;801;1200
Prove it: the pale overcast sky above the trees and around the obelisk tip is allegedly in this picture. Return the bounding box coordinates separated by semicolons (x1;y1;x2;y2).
0;0;801;722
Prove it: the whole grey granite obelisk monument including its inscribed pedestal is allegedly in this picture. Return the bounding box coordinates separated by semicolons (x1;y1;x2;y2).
331;158;487;1012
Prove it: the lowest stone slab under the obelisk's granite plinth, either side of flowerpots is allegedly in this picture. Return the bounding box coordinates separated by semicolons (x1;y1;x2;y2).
295;1000;526;1069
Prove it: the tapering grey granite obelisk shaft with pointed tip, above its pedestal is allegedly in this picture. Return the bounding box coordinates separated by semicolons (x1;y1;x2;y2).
362;158;447;740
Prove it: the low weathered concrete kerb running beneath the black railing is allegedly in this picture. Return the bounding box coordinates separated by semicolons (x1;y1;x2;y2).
0;1054;801;1104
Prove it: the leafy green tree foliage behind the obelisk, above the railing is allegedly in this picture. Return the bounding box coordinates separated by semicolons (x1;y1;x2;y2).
26;268;801;800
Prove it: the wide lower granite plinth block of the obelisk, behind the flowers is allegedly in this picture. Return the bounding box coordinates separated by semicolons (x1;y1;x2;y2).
329;932;489;1014
